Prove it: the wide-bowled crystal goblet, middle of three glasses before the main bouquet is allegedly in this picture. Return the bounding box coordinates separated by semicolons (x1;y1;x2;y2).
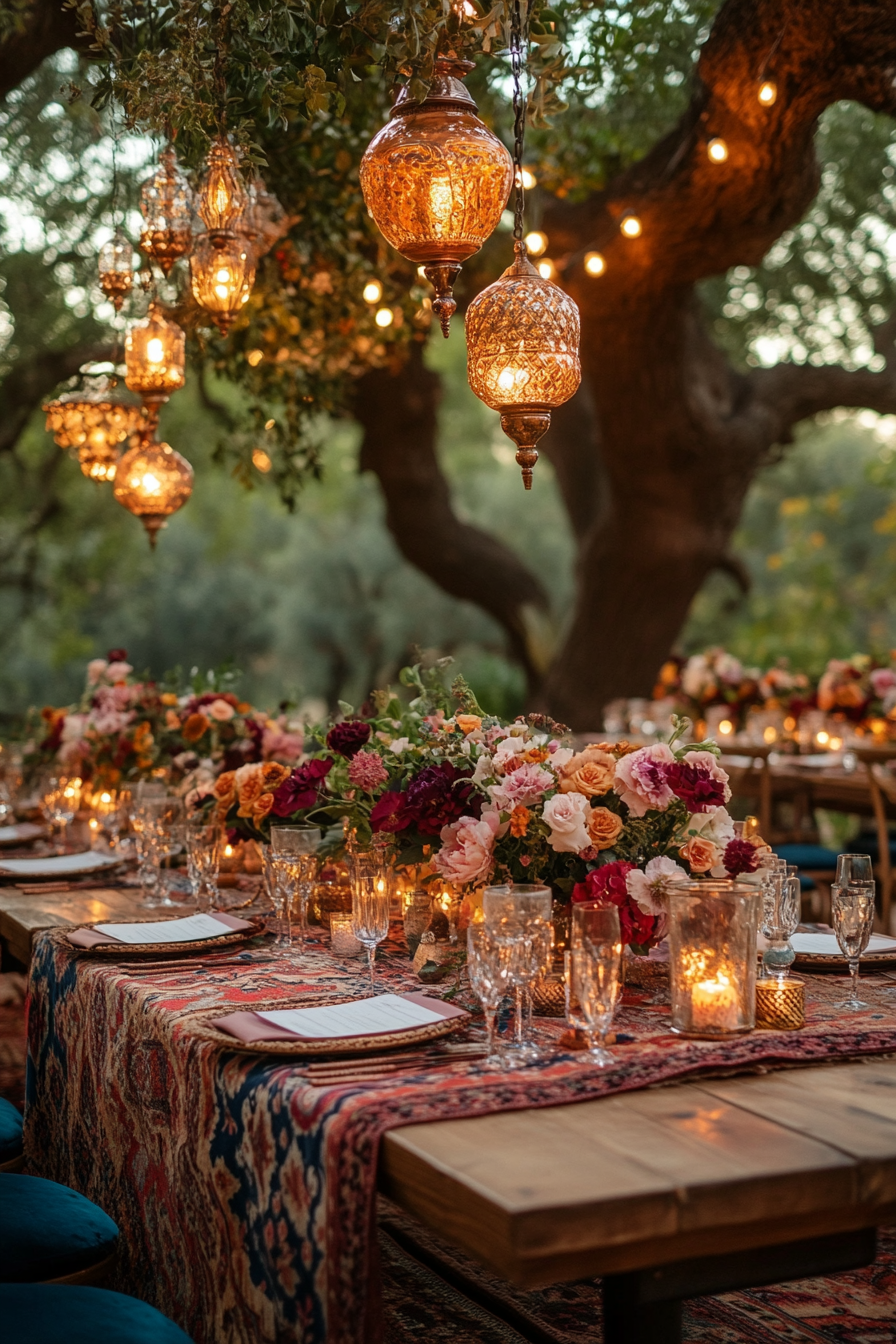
482;883;551;1068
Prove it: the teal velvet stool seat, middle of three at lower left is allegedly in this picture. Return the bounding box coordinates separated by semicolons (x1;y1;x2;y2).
0;1172;118;1284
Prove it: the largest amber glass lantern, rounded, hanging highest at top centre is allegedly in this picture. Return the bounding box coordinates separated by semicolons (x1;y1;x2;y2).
360;56;513;336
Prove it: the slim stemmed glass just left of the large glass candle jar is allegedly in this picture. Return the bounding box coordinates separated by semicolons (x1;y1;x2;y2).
571;900;622;1068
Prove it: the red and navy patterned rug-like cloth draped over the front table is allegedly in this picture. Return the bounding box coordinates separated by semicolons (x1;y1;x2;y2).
26;933;896;1344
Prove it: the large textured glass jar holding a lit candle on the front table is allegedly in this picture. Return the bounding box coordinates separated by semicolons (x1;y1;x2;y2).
669;880;762;1039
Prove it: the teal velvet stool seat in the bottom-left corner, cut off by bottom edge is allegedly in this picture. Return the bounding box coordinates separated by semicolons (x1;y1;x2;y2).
0;1284;191;1344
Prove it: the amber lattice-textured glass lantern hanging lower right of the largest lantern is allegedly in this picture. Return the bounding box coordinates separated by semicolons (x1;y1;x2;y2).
465;242;582;491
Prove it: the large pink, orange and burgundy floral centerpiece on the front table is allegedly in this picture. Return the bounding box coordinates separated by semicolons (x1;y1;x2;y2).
207;667;759;949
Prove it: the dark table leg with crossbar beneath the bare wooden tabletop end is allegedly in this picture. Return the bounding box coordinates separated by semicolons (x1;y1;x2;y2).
603;1227;877;1344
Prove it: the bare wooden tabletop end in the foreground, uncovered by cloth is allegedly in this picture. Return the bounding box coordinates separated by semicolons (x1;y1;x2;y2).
382;1063;896;1286
